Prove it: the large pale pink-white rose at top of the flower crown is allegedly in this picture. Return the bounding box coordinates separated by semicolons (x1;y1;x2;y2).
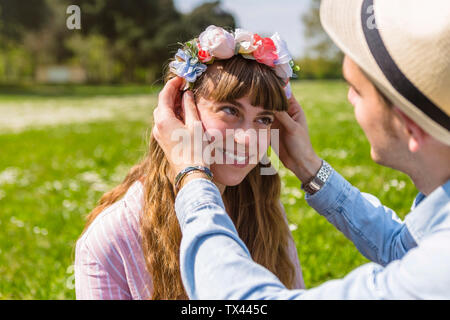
198;25;236;59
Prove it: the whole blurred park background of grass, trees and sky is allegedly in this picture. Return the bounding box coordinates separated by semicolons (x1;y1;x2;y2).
0;0;416;299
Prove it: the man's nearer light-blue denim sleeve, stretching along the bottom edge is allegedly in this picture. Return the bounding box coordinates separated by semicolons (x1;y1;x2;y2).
175;176;450;300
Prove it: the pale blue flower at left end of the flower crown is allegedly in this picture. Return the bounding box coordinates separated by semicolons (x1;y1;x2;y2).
169;49;207;83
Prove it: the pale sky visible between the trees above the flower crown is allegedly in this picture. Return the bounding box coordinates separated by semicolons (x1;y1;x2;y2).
174;0;309;58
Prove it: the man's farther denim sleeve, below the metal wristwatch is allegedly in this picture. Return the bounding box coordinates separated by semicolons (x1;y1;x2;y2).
305;170;417;266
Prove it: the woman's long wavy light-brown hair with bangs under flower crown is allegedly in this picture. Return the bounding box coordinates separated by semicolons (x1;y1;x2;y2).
83;55;295;299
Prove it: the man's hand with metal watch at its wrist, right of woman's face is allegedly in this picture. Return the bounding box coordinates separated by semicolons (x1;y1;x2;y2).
272;95;322;182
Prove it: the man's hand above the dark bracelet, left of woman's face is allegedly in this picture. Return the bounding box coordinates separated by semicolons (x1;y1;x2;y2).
152;77;209;181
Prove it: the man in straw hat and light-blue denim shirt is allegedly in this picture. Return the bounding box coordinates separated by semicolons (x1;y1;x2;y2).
153;0;450;299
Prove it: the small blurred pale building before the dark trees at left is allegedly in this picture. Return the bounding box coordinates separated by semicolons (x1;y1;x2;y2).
36;65;87;84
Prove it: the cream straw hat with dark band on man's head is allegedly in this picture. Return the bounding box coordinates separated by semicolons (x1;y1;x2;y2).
320;0;450;145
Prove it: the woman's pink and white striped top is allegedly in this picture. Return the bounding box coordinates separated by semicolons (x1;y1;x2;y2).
75;181;305;300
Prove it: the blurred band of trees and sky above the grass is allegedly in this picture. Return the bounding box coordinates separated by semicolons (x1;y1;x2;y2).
0;0;341;85
